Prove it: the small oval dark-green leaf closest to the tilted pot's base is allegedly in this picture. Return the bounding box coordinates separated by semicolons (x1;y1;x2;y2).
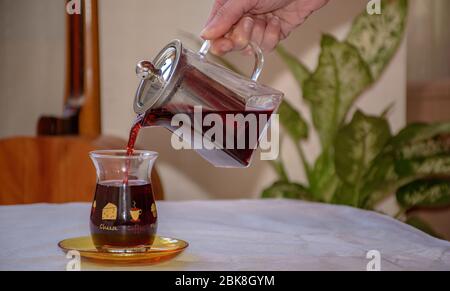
278;101;308;142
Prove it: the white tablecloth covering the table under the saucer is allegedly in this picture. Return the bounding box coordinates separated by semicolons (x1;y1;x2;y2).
0;200;450;271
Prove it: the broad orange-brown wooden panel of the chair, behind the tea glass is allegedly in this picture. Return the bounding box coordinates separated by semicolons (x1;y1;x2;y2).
0;137;164;205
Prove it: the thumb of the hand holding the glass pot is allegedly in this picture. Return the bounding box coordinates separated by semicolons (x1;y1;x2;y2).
201;0;255;39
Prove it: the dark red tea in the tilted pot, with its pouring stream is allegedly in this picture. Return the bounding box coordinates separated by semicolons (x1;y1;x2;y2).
128;66;276;168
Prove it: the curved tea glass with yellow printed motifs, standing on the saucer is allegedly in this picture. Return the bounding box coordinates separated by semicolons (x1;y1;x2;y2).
90;150;158;252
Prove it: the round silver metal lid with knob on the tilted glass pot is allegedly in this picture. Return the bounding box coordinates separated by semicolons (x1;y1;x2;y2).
134;40;182;114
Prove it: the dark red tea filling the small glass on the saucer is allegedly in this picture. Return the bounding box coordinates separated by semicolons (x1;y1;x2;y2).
90;180;157;249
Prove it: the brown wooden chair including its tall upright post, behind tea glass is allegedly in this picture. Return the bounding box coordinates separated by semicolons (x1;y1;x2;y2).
0;0;164;205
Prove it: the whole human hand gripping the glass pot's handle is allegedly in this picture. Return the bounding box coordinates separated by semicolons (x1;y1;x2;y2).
201;0;329;55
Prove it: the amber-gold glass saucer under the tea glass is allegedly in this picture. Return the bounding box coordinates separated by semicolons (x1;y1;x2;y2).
58;236;189;264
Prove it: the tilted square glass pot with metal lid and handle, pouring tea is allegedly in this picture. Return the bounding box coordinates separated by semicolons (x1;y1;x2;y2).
134;40;283;168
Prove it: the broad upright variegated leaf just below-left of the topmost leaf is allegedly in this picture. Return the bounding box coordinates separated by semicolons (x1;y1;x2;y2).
303;35;372;148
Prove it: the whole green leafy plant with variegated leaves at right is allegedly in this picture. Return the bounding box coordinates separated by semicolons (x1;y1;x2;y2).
262;0;450;237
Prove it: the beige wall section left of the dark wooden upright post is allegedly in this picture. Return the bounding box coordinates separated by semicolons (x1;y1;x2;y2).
0;0;65;138
